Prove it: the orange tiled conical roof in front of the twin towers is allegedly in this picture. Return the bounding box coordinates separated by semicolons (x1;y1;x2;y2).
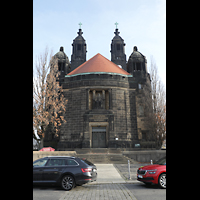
67;53;131;76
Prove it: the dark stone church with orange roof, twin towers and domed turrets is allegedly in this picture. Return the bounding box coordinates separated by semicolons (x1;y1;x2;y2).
44;28;155;150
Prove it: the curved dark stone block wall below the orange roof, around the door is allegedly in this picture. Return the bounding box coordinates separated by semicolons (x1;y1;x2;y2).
58;74;138;149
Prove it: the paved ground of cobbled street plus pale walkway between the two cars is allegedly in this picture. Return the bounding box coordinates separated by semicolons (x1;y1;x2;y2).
33;164;166;200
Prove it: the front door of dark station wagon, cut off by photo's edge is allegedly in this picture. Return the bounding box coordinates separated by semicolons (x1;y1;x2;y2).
33;158;48;183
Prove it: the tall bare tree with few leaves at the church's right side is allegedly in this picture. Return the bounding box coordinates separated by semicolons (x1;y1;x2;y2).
137;57;166;148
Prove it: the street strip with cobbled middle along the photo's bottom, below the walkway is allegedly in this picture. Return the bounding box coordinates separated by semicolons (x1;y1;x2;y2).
33;182;166;200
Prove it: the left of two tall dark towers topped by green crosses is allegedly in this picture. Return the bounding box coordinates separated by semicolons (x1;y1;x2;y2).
71;23;87;71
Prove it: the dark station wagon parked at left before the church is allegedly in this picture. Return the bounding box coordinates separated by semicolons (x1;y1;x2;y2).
33;156;97;190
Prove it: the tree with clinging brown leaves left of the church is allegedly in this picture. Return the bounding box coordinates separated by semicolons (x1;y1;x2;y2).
33;48;67;146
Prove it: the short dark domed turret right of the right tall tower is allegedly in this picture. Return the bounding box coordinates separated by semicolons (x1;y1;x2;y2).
127;46;147;74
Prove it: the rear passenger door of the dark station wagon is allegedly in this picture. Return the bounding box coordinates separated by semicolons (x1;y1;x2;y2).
43;158;65;183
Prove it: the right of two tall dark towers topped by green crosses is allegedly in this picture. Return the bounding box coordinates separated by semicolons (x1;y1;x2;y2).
110;22;126;70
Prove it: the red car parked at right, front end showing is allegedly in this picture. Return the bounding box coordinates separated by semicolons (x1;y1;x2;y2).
137;157;166;188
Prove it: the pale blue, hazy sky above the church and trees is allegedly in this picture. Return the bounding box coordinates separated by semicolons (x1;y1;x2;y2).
33;0;166;85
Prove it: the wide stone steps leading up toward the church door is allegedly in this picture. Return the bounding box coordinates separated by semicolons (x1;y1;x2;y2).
76;148;138;164
